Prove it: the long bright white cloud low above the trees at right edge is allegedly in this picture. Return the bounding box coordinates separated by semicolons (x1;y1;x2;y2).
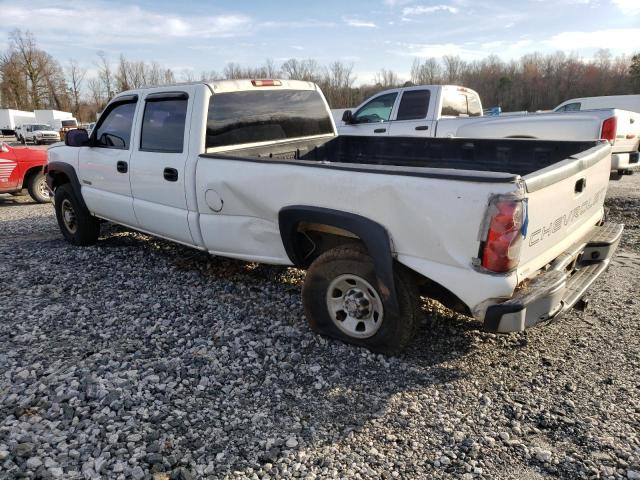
545;28;640;51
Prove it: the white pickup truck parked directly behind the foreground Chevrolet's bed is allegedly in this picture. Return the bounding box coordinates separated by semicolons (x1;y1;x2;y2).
338;85;640;174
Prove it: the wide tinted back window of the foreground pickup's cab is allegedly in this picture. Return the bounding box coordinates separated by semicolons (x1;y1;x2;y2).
206;90;333;148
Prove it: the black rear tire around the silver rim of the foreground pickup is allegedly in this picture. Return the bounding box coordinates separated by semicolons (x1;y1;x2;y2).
302;245;420;355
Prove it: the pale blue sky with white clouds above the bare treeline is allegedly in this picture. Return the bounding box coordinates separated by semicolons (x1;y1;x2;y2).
0;0;640;83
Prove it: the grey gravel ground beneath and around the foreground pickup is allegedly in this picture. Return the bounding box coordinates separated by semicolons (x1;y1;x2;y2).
0;175;640;480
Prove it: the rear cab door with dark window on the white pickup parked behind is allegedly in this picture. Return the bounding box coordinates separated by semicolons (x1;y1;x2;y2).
389;88;435;137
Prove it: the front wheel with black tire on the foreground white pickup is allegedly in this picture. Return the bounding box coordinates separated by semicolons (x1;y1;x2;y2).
54;184;100;246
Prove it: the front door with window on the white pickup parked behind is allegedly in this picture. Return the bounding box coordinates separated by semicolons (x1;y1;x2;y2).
339;90;400;137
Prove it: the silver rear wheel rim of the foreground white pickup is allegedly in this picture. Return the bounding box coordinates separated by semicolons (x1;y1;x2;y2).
327;274;384;338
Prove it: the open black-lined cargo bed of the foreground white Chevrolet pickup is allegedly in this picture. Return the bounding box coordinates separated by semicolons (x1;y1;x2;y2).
210;135;600;180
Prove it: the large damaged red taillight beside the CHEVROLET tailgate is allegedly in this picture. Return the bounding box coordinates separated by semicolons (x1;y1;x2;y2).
482;198;525;272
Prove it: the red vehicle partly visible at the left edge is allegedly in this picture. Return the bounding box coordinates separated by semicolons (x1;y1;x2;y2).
0;142;51;203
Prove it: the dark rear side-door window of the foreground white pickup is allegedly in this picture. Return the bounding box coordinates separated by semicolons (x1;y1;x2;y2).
140;98;187;153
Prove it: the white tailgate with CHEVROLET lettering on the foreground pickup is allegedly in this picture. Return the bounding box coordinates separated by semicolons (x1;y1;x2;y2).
518;143;611;281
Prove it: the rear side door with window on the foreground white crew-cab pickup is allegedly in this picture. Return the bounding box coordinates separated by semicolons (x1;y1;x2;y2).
131;86;194;245
